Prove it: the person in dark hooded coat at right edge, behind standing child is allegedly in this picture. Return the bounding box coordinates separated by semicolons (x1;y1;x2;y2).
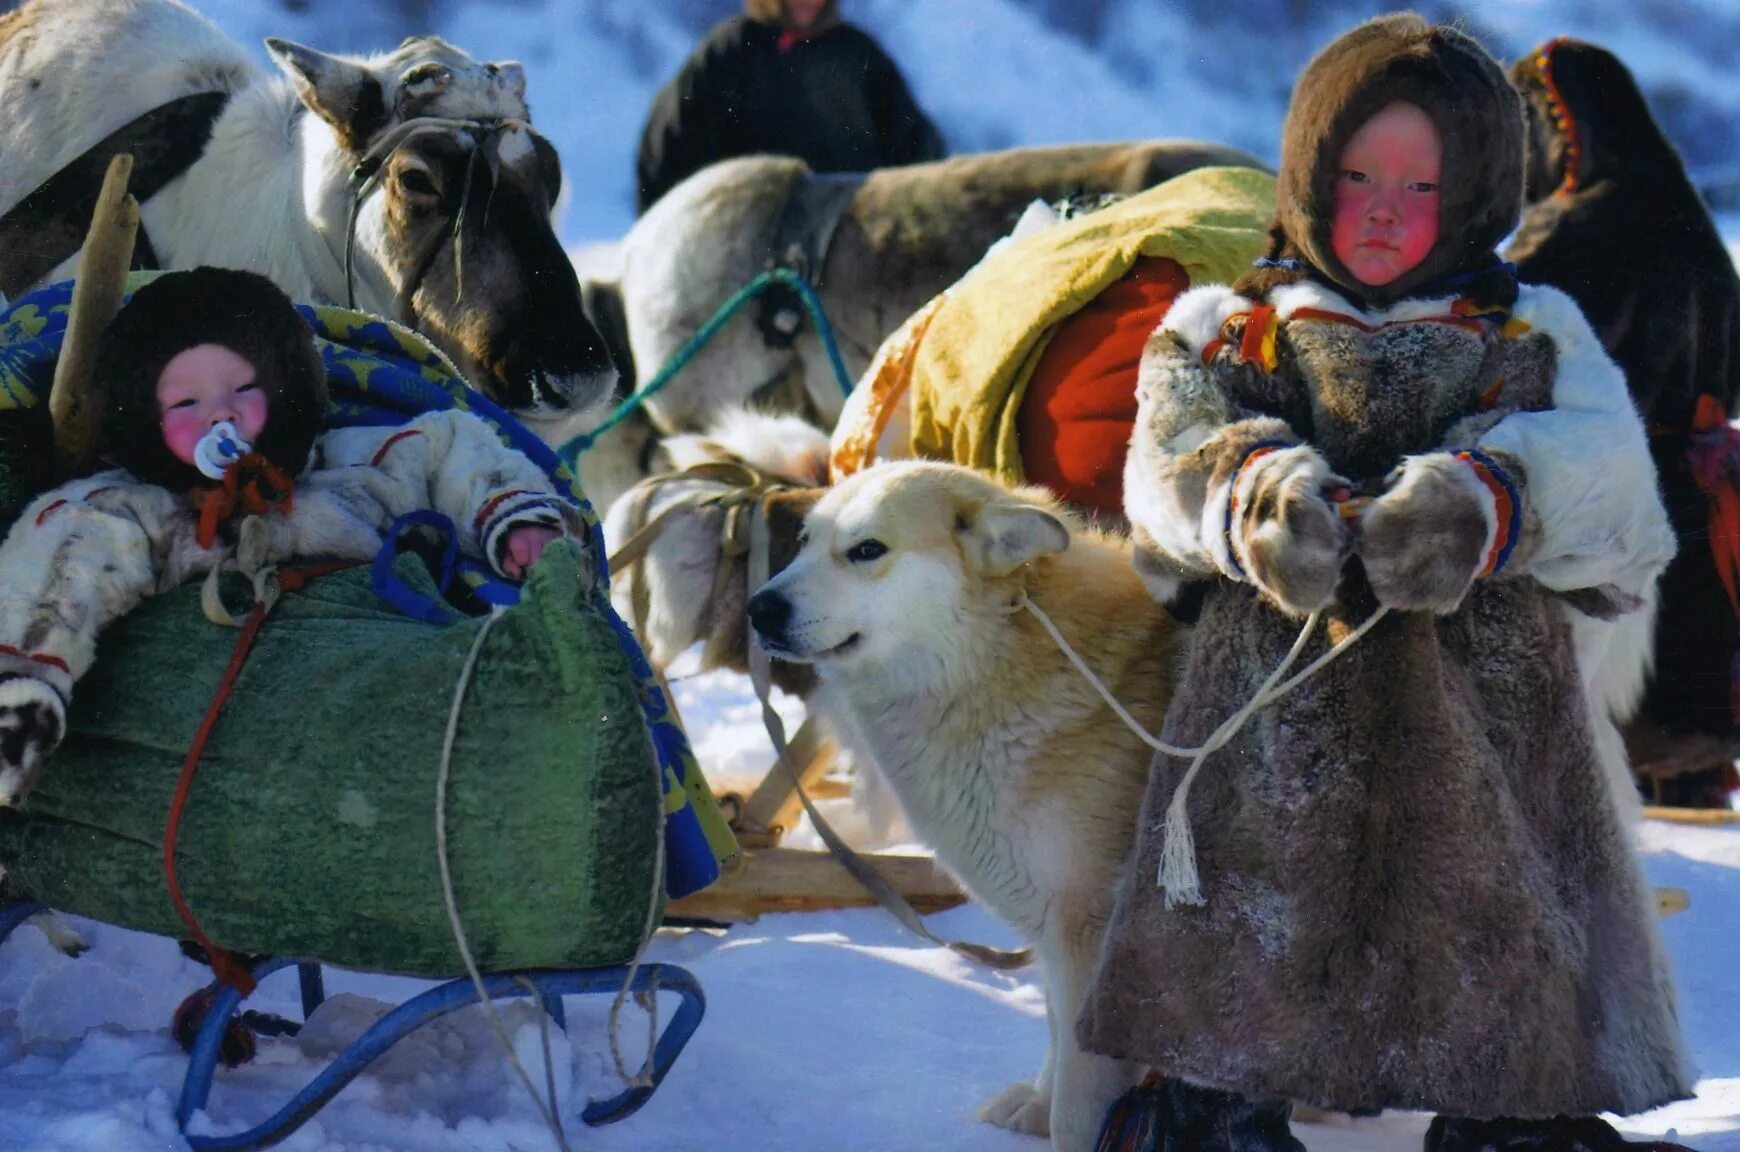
1507;40;1740;802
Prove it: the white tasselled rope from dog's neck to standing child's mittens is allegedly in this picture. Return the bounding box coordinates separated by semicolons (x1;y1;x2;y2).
1014;592;1390;908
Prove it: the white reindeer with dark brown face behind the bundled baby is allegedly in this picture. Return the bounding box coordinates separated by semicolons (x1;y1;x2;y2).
0;0;616;444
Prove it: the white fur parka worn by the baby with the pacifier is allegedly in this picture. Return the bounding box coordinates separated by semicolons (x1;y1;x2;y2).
0;405;585;806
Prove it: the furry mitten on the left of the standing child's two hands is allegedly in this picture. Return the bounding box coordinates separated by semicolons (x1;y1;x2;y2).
1234;445;1352;616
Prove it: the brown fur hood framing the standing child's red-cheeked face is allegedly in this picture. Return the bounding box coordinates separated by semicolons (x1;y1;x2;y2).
1242;12;1523;305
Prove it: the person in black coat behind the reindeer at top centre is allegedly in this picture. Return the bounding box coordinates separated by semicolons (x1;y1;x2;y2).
635;0;945;212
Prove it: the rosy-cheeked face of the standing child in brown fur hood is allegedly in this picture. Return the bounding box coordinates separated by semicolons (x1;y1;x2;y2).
1329;103;1442;287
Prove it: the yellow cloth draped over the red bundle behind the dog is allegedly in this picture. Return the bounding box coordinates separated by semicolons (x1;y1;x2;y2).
910;167;1275;484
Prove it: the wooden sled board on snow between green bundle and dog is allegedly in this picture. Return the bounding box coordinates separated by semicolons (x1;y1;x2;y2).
666;847;967;922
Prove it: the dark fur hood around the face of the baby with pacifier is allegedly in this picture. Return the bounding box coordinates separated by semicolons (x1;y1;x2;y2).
92;268;325;492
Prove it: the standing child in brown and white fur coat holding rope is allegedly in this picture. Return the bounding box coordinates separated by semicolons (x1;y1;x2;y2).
1079;14;1690;1152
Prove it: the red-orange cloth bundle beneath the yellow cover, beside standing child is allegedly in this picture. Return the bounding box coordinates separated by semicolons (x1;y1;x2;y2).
1018;256;1190;515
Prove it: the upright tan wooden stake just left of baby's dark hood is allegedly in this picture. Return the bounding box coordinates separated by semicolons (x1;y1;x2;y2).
49;153;139;475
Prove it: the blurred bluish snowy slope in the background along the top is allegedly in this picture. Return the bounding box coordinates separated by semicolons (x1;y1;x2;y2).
180;0;1740;249
